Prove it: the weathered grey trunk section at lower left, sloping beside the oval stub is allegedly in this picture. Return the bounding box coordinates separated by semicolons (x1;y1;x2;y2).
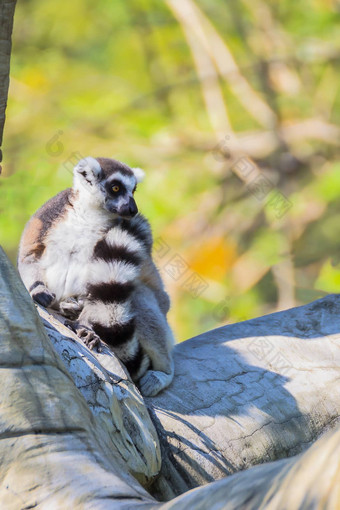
0;245;157;510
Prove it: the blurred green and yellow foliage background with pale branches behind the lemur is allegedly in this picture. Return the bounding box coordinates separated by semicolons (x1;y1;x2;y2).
0;0;340;341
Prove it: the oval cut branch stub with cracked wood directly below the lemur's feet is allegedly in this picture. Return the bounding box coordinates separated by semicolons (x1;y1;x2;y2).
38;307;161;487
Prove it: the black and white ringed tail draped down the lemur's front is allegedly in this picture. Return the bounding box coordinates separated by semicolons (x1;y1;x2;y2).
80;221;150;380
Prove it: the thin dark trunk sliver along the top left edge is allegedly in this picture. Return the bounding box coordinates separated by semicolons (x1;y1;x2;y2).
0;0;16;162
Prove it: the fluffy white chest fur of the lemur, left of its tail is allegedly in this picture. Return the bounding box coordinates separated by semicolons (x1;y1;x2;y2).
41;205;109;300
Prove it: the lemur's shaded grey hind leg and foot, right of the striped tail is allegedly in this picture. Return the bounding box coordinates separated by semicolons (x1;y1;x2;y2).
133;286;174;397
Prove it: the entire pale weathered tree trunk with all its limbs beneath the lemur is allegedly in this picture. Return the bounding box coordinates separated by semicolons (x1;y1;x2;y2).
0;246;340;510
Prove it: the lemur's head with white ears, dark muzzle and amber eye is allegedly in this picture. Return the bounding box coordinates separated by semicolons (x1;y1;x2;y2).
74;157;144;218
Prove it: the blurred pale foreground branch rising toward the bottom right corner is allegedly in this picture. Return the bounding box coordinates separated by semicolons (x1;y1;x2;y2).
160;428;340;510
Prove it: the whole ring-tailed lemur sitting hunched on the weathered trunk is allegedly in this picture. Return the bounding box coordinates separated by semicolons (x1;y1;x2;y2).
18;157;174;396
